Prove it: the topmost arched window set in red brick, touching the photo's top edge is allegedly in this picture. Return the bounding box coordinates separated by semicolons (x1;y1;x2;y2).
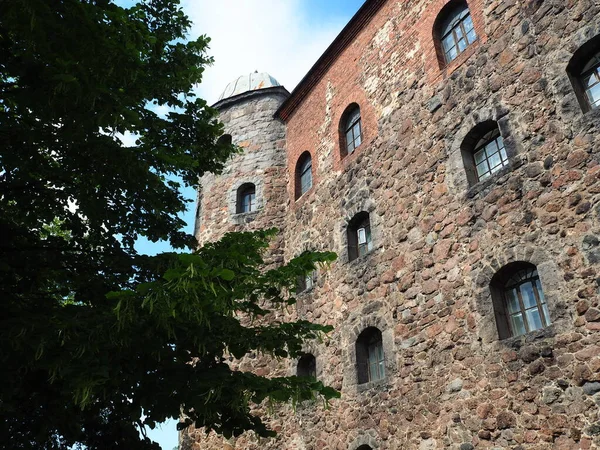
434;0;477;65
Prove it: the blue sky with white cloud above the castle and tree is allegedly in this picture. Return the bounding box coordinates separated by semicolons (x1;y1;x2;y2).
120;0;364;450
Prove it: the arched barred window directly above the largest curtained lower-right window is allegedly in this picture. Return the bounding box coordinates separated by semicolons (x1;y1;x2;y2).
461;120;508;185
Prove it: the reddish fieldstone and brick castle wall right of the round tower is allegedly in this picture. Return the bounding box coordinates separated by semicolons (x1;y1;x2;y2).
185;0;600;450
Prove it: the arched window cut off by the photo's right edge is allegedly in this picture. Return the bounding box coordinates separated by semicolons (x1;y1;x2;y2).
567;35;600;112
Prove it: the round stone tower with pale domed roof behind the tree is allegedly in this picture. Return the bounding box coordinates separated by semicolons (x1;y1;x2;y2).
195;72;290;253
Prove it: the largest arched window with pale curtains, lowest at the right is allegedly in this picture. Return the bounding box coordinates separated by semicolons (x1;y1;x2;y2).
490;262;551;339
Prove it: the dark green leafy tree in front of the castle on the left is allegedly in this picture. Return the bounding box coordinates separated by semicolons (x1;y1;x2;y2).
0;0;336;450
